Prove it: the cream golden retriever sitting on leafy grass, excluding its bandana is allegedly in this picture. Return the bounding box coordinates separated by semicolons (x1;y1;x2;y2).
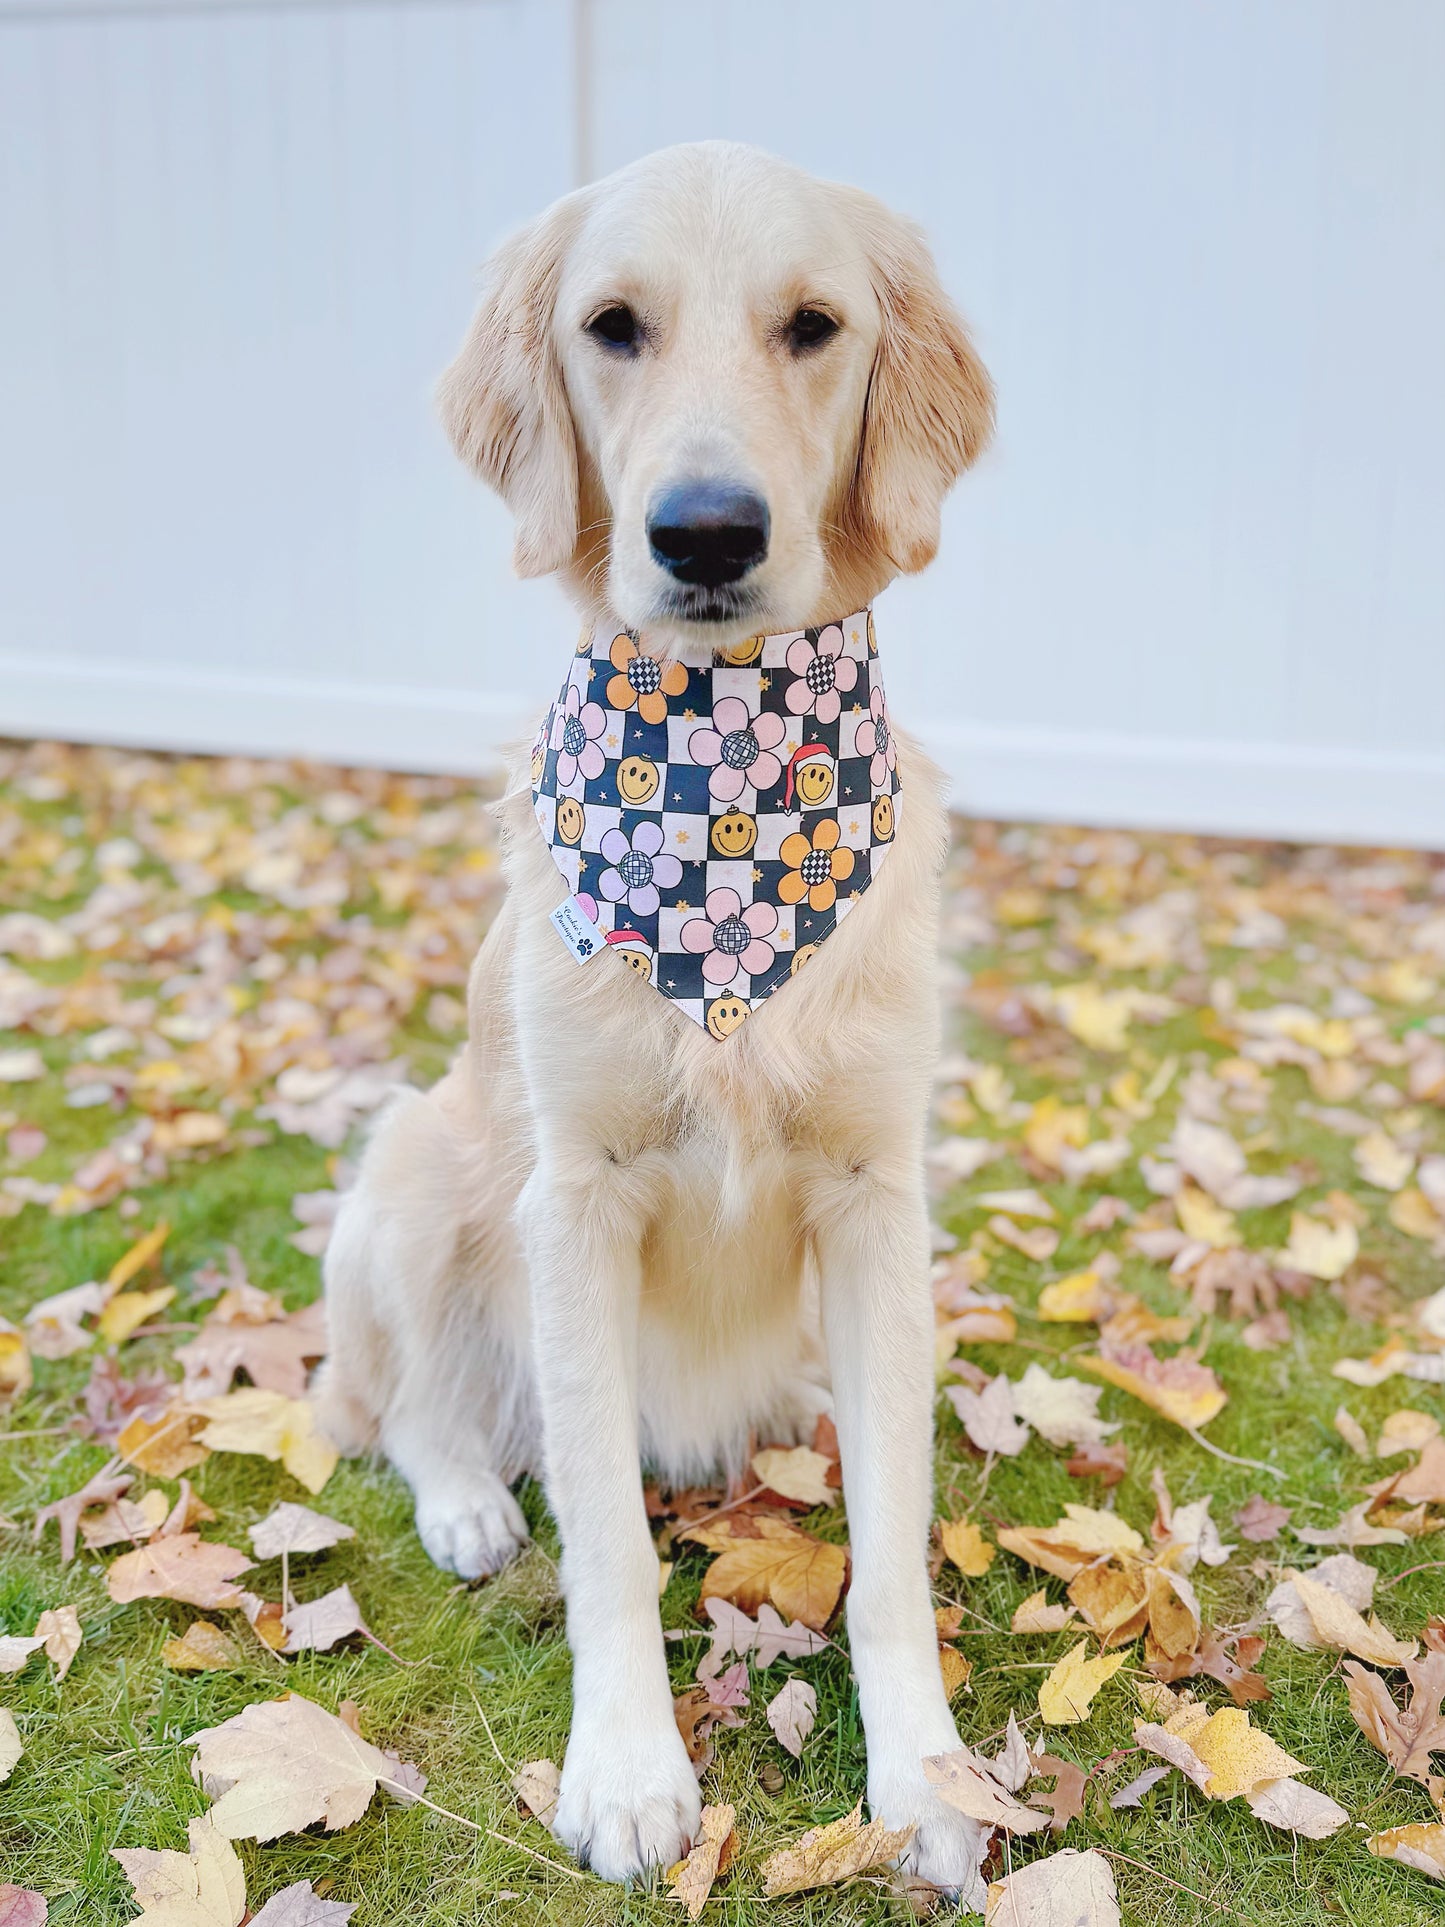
318;143;992;1904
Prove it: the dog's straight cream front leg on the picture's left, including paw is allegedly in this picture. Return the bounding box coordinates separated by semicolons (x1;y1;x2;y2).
518;1156;699;1881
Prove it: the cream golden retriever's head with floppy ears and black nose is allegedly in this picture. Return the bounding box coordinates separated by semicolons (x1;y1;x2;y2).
441;143;992;646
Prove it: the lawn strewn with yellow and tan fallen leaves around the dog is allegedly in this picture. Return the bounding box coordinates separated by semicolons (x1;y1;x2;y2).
0;746;1445;1927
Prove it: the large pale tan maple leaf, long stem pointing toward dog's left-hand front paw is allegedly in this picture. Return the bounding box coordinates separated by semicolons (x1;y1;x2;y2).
187;1694;426;1840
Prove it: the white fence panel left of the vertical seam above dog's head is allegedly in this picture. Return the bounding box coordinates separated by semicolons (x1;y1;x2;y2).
0;0;576;767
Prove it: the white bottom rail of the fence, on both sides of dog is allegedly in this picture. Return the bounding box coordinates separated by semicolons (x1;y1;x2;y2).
0;655;1445;850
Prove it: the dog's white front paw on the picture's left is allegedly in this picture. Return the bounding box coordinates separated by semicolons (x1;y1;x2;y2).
553;1721;701;1881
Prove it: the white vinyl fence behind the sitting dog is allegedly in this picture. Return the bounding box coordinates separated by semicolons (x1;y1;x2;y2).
0;0;1445;846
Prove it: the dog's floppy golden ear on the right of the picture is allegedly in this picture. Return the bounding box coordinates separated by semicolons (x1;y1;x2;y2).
846;191;994;574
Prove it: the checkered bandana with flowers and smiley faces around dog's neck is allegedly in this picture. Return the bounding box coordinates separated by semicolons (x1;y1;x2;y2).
532;611;902;1039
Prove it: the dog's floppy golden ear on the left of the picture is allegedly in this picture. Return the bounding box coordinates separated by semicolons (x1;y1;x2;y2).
437;200;578;576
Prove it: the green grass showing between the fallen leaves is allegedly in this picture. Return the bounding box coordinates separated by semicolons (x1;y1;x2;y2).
0;759;1445;1927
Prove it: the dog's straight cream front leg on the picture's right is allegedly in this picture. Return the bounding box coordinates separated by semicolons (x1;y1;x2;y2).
809;1127;985;1910
